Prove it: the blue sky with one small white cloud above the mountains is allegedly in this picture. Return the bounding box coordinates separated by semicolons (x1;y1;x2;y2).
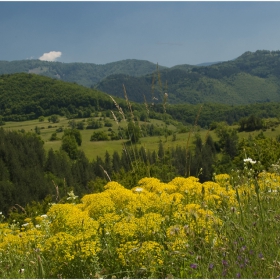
0;1;280;67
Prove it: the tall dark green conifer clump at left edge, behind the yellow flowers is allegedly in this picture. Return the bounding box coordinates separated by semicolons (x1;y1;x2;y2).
0;129;52;213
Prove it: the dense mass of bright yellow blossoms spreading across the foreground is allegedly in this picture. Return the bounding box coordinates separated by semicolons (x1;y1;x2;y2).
0;173;280;276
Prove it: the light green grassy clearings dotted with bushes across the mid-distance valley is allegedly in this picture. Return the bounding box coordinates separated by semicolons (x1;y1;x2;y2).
3;117;280;160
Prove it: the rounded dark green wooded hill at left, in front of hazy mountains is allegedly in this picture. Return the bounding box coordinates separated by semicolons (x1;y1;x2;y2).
0;73;136;121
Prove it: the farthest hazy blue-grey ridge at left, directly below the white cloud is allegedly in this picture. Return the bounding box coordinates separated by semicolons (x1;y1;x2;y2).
0;59;164;87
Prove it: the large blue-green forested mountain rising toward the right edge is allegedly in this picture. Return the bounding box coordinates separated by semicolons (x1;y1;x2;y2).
96;51;280;105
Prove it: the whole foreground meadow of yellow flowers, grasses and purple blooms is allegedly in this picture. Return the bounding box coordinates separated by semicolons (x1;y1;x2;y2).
0;162;280;278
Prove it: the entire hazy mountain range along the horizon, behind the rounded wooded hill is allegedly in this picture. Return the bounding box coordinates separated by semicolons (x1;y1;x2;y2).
0;50;280;105
